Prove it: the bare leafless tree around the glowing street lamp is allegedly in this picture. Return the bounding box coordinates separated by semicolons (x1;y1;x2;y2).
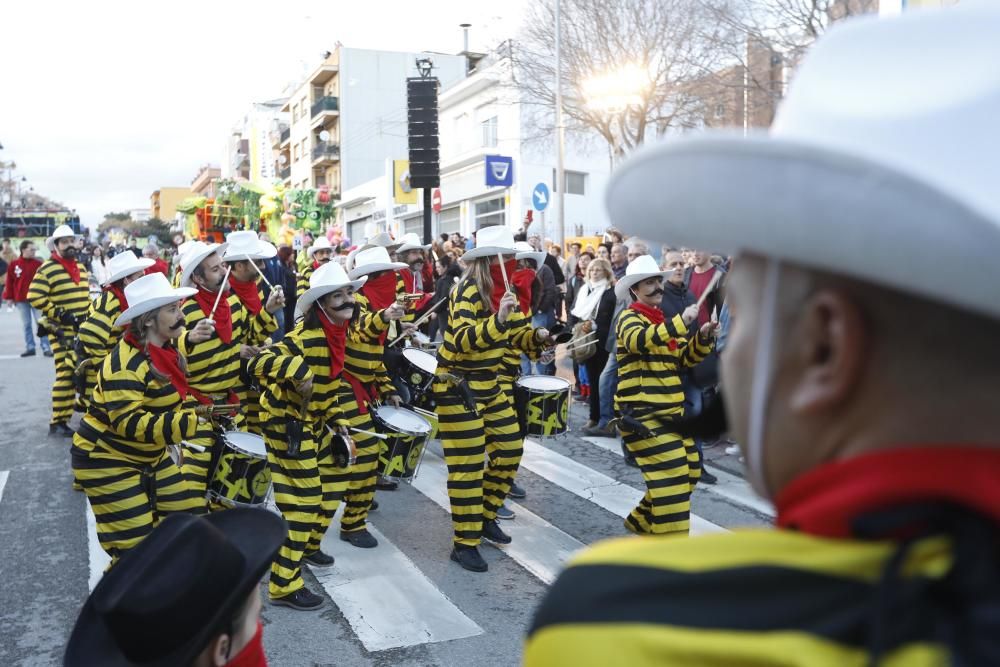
510;0;734;157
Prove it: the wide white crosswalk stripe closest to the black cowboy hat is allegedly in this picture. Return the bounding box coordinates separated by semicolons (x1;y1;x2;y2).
312;521;484;651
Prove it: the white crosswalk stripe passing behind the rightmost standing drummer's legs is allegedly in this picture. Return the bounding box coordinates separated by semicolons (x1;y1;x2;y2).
521;439;726;535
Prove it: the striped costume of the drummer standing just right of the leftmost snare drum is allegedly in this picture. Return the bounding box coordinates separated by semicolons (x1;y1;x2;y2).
248;324;349;598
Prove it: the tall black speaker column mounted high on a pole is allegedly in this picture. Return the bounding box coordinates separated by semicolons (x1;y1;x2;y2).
406;78;441;188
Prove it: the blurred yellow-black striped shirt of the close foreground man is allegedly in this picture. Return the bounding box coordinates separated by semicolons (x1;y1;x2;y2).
524;530;952;667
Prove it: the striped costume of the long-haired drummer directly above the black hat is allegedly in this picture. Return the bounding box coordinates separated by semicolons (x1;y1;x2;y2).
73;340;205;560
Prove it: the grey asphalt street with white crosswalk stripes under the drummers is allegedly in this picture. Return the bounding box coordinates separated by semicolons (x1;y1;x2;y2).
0;309;769;667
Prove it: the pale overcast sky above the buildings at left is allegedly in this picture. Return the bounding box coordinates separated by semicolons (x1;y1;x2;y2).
0;0;526;225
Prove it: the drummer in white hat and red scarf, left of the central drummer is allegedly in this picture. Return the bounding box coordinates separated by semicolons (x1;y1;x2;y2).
340;245;413;508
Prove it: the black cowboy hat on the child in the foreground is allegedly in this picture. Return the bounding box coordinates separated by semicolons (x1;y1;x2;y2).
64;509;287;667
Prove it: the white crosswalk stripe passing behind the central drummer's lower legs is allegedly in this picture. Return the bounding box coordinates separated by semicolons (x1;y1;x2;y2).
413;452;586;584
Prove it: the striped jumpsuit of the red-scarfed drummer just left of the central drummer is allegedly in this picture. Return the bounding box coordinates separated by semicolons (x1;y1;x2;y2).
339;292;396;533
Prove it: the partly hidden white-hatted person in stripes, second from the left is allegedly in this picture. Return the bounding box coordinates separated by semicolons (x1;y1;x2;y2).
76;252;153;407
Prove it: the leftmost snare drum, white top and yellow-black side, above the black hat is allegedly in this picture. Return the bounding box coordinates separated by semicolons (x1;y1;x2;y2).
208;431;271;507
